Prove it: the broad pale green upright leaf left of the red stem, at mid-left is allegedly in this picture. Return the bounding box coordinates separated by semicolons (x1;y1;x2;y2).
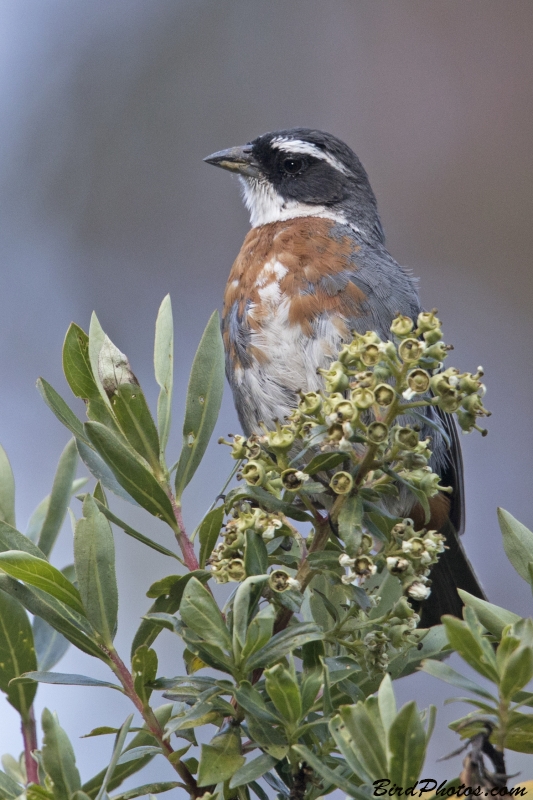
73;495;118;646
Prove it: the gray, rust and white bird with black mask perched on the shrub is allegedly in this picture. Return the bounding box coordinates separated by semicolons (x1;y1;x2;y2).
204;127;485;627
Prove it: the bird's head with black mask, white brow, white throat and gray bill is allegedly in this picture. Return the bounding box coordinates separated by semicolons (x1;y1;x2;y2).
204;128;383;241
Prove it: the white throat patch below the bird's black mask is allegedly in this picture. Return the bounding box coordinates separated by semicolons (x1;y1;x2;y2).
239;175;348;228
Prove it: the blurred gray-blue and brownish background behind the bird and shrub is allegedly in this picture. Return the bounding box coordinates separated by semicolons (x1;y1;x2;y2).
0;0;533;780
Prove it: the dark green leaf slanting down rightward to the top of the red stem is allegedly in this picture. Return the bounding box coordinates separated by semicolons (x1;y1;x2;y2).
85;422;176;530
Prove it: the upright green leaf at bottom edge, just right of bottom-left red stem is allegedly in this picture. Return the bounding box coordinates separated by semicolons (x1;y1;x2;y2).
41;708;81;800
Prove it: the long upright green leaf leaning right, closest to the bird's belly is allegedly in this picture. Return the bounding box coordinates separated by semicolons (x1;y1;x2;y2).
176;311;224;501
